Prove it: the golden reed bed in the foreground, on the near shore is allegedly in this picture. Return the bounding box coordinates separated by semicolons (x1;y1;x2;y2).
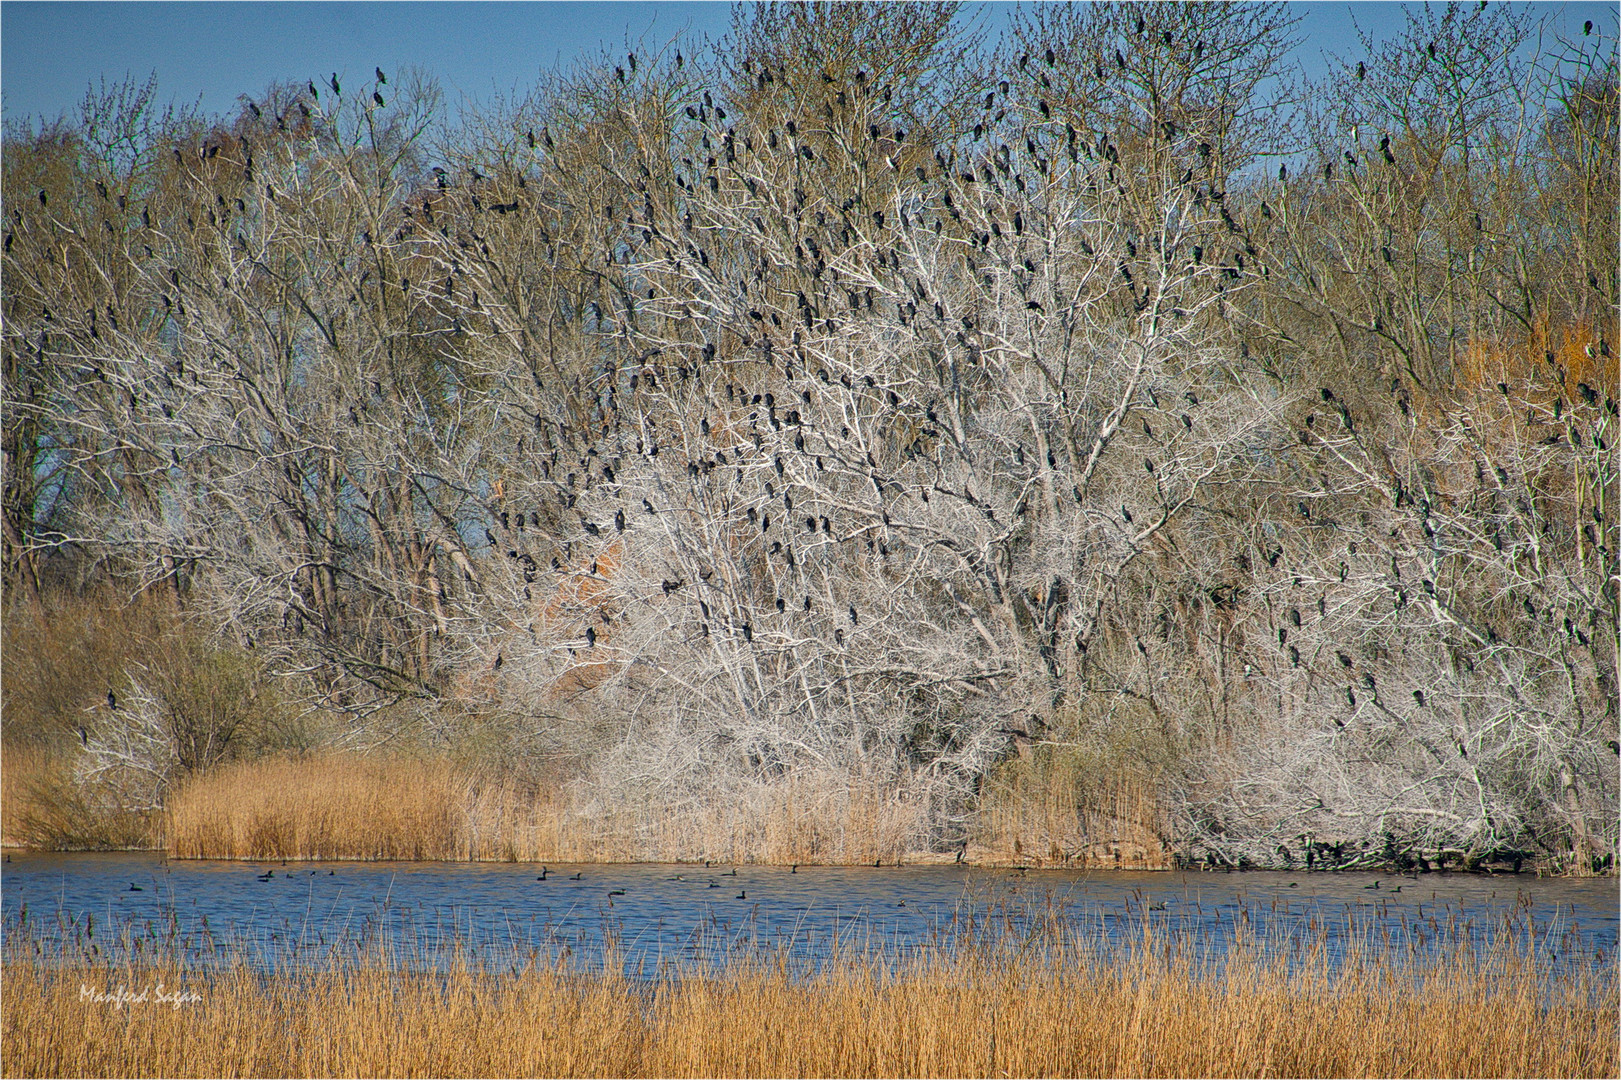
0;926;1621;1077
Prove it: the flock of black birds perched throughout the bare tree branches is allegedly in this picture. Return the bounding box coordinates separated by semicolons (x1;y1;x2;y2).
3;18;1616;752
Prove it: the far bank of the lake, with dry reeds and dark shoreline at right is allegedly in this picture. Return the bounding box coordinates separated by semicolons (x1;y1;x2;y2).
19;754;1615;874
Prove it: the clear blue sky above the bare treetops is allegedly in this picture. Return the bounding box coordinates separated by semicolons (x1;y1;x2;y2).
0;0;1616;129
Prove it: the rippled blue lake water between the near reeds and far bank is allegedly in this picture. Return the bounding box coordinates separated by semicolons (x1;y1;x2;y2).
0;853;1621;975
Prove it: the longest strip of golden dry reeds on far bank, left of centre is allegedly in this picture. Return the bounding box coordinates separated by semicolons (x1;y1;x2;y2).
164;754;922;864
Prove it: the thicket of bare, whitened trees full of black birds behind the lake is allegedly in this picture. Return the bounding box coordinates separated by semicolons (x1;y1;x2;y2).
3;5;1618;864
